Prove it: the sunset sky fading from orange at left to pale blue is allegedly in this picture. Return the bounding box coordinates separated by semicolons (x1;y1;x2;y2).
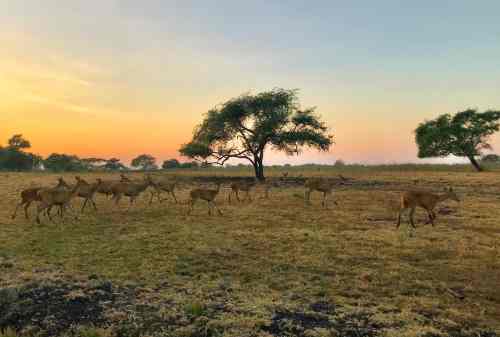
0;0;500;164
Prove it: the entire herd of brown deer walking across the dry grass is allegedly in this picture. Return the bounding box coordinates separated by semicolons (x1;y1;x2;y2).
12;174;460;228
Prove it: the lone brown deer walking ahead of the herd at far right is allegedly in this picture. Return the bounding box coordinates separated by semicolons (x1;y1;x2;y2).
397;187;460;228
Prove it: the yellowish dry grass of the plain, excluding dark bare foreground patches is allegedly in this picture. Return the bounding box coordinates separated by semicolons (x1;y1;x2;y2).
0;171;500;336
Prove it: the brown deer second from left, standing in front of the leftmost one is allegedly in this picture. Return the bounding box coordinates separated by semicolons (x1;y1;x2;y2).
36;181;82;224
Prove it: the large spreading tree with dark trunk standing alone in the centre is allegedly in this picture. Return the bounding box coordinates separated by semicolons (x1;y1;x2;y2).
179;88;333;180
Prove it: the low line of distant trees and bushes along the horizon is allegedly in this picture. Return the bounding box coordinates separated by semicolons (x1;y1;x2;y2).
0;134;500;172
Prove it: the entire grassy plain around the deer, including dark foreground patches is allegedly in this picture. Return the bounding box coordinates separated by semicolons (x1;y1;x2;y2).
0;167;500;337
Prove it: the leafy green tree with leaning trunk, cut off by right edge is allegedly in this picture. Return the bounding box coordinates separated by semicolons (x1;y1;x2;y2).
415;109;500;171
